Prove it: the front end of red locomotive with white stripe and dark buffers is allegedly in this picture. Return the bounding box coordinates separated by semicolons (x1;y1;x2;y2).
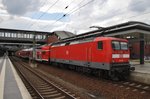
110;40;134;79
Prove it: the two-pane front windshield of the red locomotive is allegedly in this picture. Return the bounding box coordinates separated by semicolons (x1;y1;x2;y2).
112;41;128;50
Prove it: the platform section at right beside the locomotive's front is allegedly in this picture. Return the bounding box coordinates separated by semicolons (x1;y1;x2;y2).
130;61;150;84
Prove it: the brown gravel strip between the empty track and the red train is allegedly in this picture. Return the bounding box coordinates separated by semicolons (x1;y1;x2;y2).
37;64;150;99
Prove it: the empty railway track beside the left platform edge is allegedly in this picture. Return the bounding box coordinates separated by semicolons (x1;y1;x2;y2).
11;58;80;99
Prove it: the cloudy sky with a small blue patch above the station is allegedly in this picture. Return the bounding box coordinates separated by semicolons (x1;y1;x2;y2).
0;0;150;34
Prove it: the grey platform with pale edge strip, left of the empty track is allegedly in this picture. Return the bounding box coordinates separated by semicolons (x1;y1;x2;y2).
0;56;32;99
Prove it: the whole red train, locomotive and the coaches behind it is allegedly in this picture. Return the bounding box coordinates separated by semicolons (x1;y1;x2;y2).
16;37;134;80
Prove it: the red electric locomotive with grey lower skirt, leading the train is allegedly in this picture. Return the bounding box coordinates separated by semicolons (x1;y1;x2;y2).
50;37;130;78
